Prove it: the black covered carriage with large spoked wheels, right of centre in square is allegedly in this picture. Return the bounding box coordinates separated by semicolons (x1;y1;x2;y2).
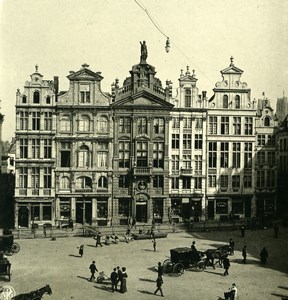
163;247;205;276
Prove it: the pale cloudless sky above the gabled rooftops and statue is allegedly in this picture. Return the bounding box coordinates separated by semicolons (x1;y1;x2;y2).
0;0;288;140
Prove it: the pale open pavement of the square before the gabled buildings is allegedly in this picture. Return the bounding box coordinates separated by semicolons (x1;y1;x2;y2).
0;228;288;300
